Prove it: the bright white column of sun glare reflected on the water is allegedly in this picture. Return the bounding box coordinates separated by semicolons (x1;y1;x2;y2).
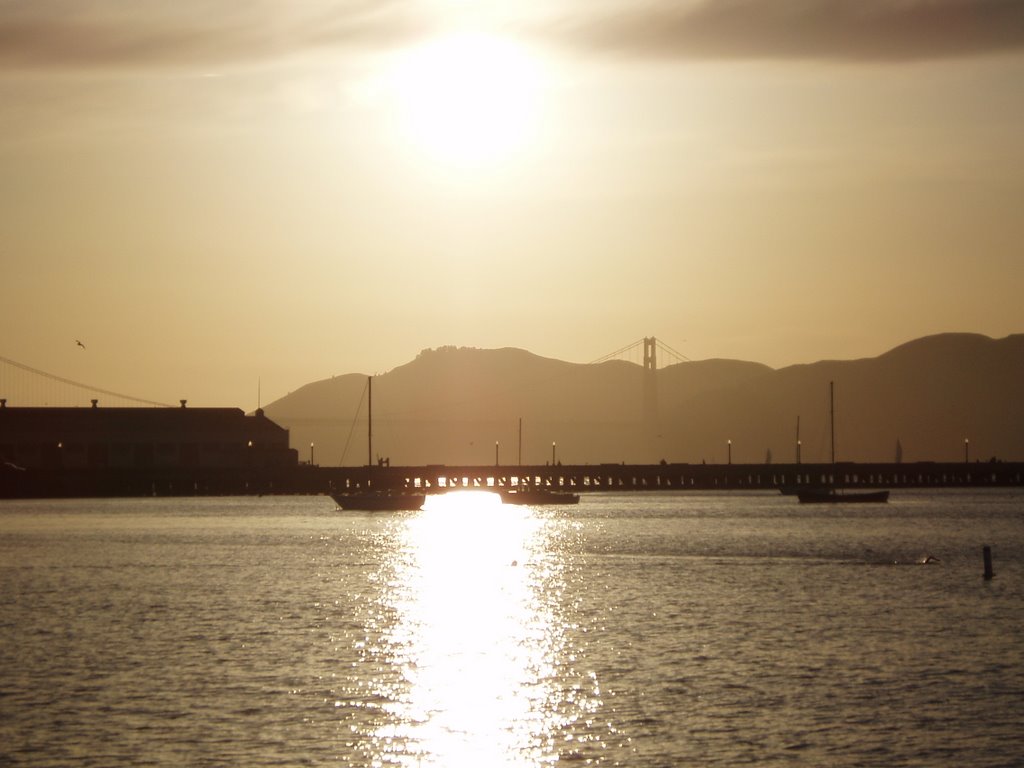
376;492;577;768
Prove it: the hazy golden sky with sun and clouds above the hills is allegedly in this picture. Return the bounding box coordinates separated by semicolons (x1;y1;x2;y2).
0;0;1024;409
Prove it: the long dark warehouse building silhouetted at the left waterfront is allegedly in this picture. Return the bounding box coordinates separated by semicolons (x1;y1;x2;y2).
0;399;298;498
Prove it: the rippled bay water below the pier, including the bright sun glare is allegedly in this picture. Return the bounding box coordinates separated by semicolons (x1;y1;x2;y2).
0;492;1024;768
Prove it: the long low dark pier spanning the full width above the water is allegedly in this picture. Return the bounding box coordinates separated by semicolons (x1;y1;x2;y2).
0;462;1024;499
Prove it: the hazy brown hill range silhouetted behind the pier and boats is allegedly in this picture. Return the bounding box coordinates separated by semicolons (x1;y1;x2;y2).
264;334;1024;466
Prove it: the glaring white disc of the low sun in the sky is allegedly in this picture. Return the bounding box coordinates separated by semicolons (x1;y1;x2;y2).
391;34;541;166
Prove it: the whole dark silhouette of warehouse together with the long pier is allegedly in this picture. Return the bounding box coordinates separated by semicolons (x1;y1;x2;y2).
0;399;1024;499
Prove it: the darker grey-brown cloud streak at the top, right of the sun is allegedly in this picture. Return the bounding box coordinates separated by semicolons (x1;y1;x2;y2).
549;0;1024;61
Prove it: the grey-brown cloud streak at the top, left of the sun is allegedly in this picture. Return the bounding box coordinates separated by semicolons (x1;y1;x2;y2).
0;0;429;69
